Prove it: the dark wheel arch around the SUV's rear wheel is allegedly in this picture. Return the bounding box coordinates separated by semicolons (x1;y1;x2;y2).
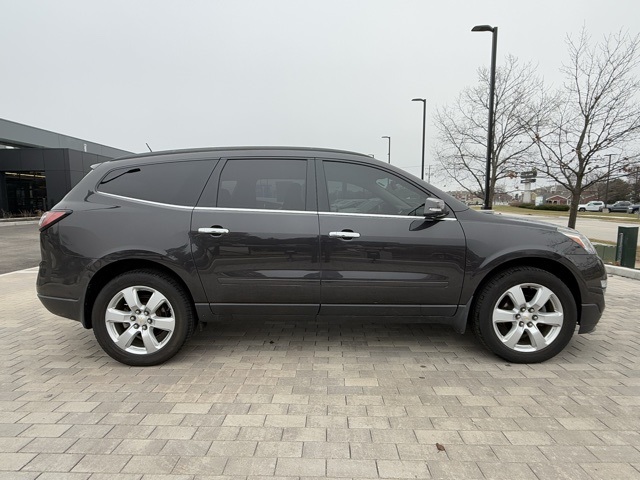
82;259;198;328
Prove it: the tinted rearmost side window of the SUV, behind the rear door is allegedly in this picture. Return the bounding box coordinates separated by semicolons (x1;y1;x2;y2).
98;160;215;206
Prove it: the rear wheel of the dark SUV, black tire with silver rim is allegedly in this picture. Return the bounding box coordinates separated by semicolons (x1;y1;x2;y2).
92;270;195;367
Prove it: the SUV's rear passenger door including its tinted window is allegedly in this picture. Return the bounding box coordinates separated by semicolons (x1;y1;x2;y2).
191;157;320;314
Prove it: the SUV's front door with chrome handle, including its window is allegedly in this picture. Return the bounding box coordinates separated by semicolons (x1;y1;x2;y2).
318;160;465;316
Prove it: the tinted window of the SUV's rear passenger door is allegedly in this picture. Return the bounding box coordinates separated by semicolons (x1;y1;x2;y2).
217;159;307;210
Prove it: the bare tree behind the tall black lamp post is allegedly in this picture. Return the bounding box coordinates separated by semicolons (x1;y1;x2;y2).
434;55;548;205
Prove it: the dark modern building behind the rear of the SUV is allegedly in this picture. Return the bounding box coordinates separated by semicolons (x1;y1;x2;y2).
0;118;131;217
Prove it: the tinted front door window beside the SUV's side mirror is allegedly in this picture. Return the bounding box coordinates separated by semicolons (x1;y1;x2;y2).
324;161;427;215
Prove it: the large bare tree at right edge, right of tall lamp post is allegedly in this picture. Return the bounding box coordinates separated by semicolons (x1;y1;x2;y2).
531;28;640;228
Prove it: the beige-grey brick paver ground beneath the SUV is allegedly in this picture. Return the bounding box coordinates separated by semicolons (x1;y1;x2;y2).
0;272;640;480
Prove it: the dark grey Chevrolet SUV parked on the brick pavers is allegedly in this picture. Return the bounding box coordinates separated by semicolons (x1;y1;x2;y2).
37;147;607;365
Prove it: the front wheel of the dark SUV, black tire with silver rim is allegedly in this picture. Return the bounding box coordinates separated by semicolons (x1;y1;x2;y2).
472;267;578;363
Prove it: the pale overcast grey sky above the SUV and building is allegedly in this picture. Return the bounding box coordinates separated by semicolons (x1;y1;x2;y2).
0;0;640;187
